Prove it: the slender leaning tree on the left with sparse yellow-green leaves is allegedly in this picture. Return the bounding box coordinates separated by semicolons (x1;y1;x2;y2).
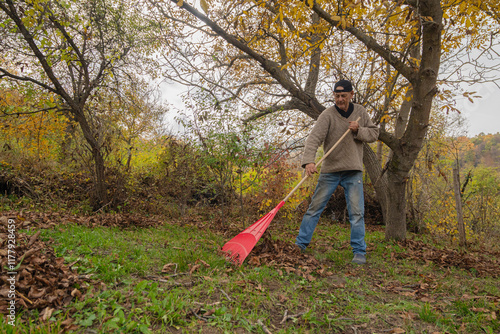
0;0;154;208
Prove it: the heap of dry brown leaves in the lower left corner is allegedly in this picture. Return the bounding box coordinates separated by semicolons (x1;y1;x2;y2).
0;216;84;326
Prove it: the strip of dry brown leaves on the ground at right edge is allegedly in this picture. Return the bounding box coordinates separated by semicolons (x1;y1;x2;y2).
396;239;500;277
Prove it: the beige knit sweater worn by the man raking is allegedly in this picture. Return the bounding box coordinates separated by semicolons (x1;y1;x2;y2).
302;104;379;173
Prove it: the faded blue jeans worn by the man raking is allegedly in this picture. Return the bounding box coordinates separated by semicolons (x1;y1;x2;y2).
295;171;366;255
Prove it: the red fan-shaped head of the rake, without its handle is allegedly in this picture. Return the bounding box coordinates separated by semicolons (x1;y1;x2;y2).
222;201;285;266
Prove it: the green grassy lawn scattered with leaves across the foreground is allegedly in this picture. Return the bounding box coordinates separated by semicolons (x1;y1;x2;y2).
0;214;500;333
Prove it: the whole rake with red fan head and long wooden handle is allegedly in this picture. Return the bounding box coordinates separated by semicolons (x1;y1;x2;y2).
222;117;361;266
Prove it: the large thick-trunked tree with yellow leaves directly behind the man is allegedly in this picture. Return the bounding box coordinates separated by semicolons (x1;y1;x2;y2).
150;0;498;239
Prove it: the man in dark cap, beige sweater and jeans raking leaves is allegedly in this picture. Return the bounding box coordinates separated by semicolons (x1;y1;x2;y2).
295;80;378;264
